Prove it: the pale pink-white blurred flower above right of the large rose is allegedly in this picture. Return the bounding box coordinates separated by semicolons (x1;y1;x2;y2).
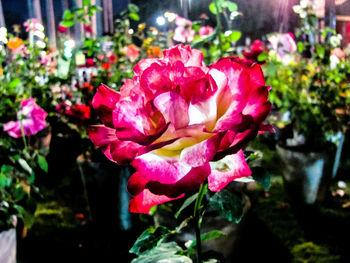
267;33;297;58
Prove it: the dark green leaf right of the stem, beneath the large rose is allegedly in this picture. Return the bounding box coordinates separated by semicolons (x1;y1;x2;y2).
209;189;243;223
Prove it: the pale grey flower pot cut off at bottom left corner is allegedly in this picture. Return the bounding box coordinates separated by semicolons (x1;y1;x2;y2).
0;228;17;263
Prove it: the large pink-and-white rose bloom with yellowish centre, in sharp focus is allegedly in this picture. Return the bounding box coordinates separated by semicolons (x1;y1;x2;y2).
89;45;271;213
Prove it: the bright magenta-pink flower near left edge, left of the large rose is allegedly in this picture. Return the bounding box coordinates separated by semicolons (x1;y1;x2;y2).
4;98;47;138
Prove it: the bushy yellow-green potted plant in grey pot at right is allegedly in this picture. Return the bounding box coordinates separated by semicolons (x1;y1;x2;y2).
265;1;350;204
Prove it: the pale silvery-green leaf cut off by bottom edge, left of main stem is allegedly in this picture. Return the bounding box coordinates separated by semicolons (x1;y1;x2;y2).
131;242;192;263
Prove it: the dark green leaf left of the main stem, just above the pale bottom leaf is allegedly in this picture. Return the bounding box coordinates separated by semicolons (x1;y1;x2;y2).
129;226;170;256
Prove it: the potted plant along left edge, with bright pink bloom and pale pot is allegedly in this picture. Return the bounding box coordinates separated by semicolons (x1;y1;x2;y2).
0;19;49;263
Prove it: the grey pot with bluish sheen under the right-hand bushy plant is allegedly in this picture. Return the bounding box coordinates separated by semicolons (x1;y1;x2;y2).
276;145;333;204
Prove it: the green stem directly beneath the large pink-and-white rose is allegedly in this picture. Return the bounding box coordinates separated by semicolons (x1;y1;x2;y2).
193;183;207;263
